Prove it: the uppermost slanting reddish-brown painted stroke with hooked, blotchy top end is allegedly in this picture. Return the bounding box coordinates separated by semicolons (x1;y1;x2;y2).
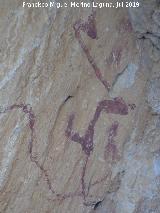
73;14;110;90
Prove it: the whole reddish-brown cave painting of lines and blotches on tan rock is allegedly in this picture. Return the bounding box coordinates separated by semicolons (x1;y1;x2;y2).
0;11;135;205
